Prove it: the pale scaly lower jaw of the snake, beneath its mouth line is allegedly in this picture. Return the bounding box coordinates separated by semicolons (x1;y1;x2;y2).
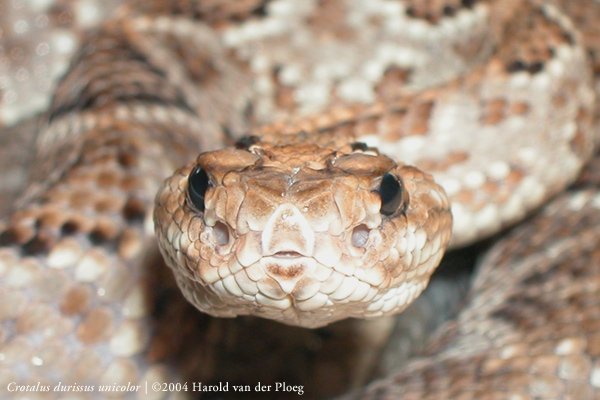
166;250;434;328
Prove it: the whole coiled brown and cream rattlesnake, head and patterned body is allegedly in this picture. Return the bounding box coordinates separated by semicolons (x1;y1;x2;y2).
0;0;600;399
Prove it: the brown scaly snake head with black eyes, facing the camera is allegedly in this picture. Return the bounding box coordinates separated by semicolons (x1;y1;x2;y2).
155;141;452;327
